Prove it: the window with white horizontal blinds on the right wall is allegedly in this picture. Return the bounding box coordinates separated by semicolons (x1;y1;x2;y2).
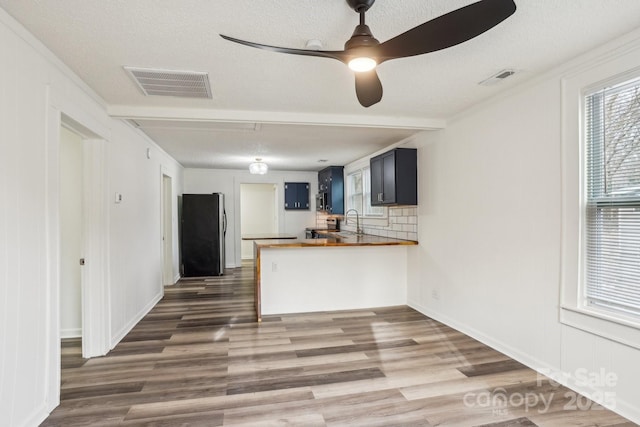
583;79;640;316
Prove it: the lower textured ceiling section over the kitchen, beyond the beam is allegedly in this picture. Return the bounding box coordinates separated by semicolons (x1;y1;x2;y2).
136;120;414;170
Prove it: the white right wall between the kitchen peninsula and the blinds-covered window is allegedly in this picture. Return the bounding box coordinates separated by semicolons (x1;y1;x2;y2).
408;30;640;422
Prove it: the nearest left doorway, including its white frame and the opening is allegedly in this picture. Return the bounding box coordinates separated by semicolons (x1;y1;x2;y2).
44;106;111;410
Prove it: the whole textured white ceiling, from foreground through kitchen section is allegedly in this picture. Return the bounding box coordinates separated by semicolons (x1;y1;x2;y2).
0;0;640;169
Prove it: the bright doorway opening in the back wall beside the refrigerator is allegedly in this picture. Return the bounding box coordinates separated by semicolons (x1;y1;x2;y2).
240;184;278;260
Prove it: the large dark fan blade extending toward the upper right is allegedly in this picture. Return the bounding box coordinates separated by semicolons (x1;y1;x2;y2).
378;0;516;63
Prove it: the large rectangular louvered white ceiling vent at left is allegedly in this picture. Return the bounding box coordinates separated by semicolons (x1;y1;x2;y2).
124;67;211;98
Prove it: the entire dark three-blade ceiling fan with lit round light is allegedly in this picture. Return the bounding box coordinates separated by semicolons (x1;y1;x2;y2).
220;0;516;107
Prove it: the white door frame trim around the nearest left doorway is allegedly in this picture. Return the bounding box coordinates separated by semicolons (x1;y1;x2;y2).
44;86;111;412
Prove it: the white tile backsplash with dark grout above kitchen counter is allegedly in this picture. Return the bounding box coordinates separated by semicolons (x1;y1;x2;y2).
316;206;418;241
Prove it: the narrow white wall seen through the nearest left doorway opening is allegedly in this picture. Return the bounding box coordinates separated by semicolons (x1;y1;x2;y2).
60;127;83;338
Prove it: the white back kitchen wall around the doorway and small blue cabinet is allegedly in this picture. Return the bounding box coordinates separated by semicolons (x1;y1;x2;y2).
184;169;318;268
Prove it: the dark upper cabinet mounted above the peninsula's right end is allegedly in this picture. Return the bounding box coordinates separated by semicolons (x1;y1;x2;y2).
370;148;418;206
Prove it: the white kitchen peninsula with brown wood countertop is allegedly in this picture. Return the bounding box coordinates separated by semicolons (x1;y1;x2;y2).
254;232;418;321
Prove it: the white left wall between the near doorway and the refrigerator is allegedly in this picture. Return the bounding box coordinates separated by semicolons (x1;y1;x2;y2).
108;118;182;345
